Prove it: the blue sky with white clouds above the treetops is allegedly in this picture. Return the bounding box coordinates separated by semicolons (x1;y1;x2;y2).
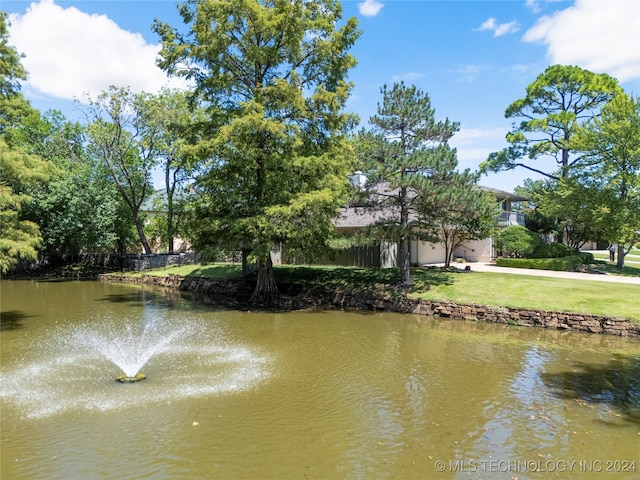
5;0;640;190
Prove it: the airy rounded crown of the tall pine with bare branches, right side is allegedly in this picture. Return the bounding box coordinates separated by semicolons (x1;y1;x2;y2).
481;65;621;180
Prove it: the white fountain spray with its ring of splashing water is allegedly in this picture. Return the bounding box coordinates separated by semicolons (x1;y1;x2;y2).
0;311;269;418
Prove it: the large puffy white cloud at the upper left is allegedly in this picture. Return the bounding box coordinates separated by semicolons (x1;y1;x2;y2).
10;0;183;100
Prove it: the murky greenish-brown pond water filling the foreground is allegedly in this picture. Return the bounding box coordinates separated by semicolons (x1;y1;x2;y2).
0;281;640;480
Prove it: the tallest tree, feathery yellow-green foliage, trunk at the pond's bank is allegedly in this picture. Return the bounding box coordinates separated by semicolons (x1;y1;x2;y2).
155;0;359;301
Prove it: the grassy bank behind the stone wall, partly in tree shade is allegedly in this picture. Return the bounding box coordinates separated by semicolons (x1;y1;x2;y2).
131;264;640;323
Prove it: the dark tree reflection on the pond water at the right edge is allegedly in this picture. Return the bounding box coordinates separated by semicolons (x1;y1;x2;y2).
541;355;640;424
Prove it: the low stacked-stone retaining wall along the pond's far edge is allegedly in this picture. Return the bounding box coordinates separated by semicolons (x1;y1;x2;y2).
98;273;640;338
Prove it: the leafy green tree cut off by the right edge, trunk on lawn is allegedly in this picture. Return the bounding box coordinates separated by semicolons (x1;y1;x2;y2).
572;93;640;268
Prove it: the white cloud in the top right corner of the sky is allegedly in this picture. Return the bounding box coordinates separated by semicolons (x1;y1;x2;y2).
522;0;640;82
